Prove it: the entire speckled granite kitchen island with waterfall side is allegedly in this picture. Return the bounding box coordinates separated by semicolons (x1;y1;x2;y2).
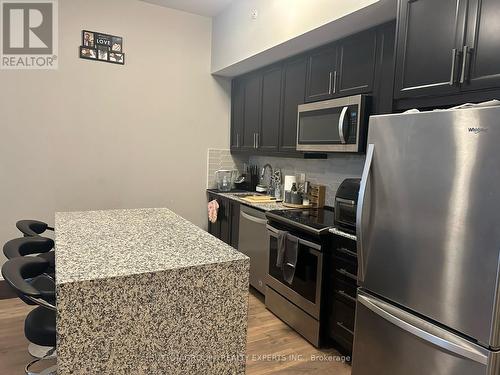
55;209;249;375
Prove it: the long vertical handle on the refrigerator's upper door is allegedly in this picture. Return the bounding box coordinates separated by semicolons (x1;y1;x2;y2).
356;143;375;283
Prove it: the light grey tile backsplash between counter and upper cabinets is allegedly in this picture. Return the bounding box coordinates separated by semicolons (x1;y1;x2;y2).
249;154;365;206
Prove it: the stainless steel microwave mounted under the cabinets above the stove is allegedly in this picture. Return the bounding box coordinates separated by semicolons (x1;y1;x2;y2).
297;95;369;152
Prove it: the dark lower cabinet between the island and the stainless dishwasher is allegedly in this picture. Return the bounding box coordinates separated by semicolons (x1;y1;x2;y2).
207;192;240;249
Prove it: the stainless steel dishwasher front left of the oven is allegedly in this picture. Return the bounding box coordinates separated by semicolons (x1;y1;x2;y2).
238;205;269;295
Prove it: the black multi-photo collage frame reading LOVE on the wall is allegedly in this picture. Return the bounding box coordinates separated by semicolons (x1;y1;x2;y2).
79;30;125;65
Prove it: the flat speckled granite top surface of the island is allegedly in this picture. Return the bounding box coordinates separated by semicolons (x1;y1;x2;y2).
56;208;248;284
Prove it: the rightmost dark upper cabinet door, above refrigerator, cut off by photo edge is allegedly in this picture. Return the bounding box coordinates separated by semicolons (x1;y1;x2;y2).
461;0;500;90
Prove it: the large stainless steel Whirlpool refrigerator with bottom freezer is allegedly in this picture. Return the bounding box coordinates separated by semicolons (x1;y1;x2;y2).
352;107;500;375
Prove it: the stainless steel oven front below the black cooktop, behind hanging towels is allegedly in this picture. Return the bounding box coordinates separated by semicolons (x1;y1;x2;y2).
266;224;323;346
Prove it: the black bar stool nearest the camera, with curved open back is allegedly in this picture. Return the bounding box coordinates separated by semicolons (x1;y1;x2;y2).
2;257;57;375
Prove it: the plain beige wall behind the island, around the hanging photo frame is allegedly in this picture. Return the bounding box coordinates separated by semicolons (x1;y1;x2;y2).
0;0;230;264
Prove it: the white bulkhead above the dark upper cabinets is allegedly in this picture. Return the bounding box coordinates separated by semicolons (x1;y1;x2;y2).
212;0;396;76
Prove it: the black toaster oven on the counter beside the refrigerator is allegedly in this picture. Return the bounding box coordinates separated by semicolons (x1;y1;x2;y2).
335;178;361;234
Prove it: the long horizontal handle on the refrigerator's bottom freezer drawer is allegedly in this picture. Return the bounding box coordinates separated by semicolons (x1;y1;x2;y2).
358;291;489;366
